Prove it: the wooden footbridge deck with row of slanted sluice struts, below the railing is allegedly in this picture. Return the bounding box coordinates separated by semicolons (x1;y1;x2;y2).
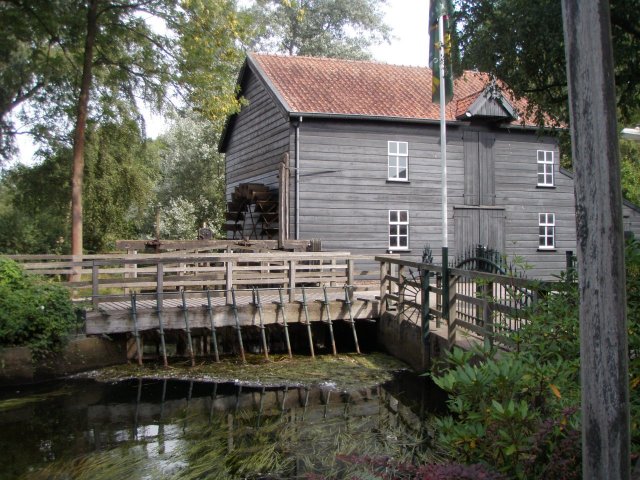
86;285;378;360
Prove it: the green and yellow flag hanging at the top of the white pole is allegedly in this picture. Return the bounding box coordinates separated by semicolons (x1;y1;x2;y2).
429;0;453;103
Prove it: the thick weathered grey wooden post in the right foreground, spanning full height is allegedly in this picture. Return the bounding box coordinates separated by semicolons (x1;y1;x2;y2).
562;0;630;480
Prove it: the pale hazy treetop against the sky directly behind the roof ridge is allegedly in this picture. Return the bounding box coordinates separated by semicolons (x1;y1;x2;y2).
245;0;390;59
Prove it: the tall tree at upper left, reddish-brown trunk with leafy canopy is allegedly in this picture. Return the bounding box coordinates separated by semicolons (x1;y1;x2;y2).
0;0;250;255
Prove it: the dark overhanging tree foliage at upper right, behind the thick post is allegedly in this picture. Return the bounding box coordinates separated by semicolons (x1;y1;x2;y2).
456;0;640;124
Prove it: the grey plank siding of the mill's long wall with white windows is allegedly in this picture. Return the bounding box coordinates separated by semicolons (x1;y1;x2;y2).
290;118;640;278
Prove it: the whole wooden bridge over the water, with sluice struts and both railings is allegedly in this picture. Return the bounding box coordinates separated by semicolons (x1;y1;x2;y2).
12;249;553;366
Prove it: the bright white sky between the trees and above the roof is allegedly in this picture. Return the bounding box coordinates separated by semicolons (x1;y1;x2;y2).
18;0;429;164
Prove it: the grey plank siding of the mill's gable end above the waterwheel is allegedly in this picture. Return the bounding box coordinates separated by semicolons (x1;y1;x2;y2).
226;69;291;200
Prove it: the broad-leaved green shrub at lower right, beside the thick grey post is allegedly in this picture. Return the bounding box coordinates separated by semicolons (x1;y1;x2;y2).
434;347;574;478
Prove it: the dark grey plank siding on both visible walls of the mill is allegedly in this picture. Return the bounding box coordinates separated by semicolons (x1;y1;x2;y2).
226;71;640;278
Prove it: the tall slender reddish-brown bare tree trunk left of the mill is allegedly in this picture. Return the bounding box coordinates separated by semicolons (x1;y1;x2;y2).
71;0;99;280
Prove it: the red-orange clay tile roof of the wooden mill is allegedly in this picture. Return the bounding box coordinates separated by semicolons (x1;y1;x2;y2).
251;53;536;126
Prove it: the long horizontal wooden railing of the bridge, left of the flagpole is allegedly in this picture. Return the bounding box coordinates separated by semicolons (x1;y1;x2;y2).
9;252;373;305
